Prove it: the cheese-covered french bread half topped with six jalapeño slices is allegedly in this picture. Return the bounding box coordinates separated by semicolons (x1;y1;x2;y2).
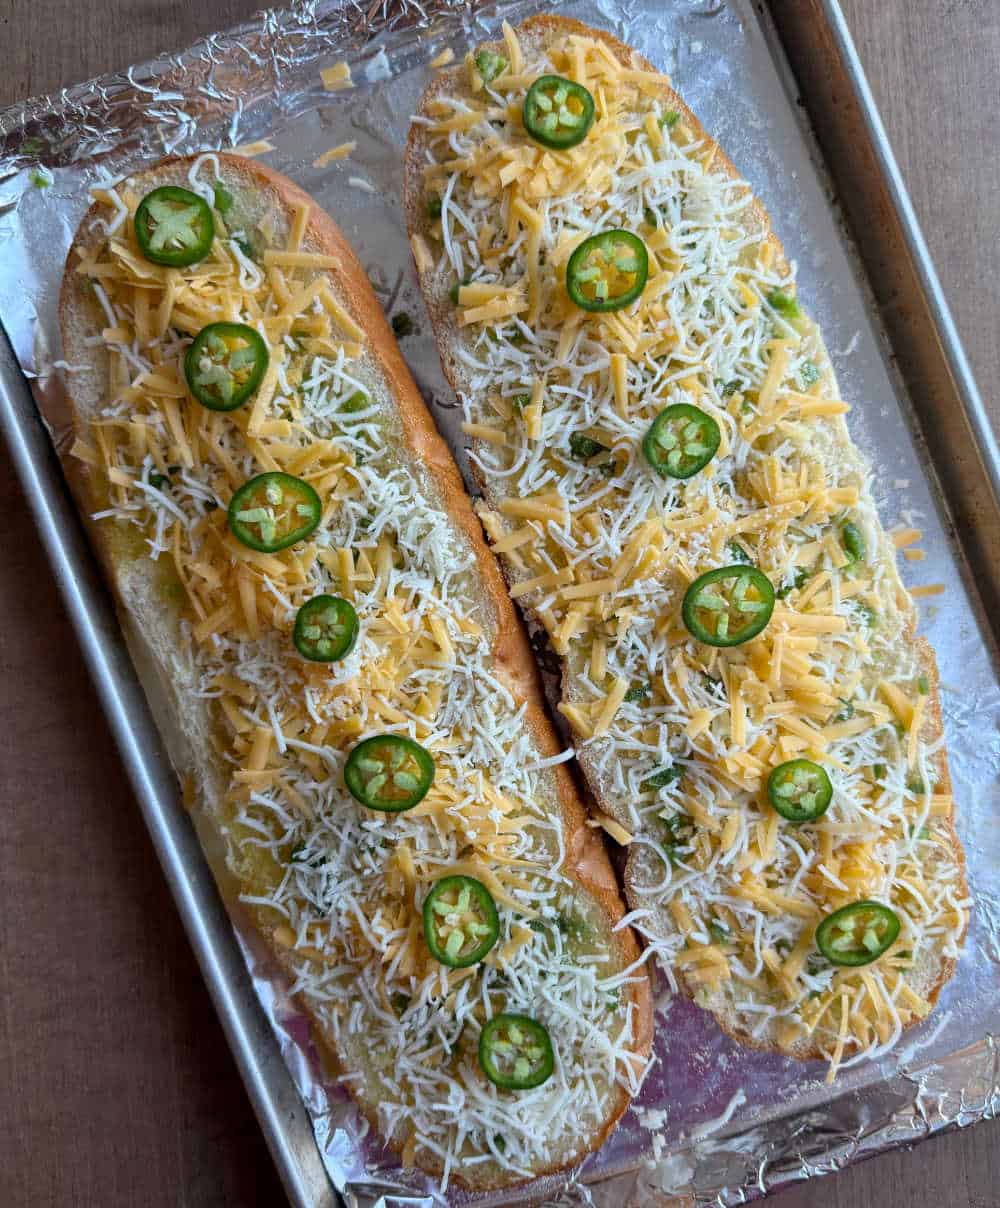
406;16;969;1078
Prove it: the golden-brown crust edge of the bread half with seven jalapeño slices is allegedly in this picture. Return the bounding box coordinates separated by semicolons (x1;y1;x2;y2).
59;152;652;1190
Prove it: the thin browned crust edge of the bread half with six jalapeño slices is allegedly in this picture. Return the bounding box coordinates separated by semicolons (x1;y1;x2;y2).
405;14;967;1061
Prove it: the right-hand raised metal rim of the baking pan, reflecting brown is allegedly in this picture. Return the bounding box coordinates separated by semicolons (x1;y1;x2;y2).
761;0;1000;640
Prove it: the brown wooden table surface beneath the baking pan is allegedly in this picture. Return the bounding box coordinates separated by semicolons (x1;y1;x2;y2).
0;0;1000;1208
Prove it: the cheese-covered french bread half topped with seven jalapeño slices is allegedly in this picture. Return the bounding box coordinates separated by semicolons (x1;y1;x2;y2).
60;153;651;1189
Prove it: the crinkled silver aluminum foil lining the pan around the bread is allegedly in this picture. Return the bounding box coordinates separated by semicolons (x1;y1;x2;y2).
0;0;1000;1208
